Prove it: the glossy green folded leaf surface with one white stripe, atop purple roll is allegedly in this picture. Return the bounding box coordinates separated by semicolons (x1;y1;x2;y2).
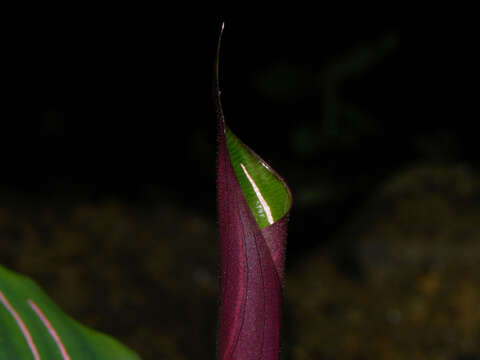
225;127;292;229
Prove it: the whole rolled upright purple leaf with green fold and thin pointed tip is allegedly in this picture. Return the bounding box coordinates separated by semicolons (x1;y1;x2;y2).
215;25;292;360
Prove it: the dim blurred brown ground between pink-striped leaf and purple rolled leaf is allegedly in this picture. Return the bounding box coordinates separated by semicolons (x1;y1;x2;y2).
0;199;217;359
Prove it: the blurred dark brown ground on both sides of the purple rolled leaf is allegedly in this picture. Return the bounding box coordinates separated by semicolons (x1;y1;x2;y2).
0;164;480;360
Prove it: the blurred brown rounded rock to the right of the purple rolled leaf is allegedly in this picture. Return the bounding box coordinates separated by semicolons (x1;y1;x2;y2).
286;164;480;360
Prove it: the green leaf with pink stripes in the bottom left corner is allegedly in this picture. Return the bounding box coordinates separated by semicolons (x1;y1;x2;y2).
0;266;139;360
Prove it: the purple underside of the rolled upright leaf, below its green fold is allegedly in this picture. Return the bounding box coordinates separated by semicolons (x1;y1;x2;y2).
217;108;288;360
